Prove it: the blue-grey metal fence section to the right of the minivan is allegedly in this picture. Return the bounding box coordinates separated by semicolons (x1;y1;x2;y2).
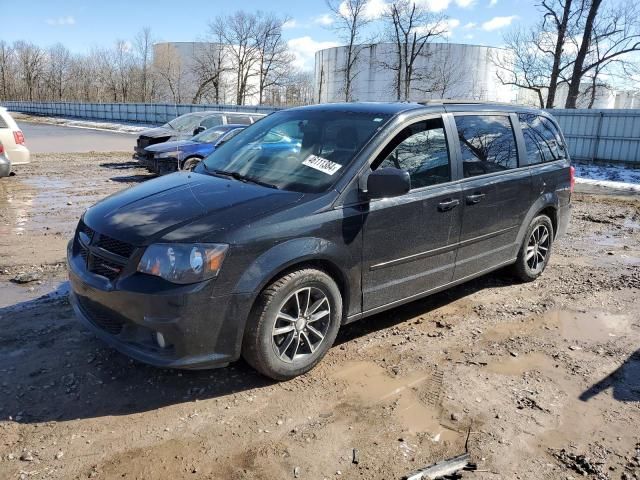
549;109;640;167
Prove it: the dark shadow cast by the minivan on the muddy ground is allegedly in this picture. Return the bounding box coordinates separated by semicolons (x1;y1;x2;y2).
0;275;511;423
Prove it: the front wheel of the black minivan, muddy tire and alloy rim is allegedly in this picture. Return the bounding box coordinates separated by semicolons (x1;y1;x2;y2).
242;268;342;380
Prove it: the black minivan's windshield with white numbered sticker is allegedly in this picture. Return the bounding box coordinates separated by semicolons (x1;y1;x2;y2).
201;110;390;192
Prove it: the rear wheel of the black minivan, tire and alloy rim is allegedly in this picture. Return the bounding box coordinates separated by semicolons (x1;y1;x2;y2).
513;215;554;282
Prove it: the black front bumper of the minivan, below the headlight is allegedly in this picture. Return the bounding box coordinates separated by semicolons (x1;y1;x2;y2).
67;242;251;369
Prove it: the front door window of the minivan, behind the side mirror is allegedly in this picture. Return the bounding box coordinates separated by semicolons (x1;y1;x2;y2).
373;118;451;189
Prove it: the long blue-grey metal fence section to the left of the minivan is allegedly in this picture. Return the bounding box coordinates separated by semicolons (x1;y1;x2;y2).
2;102;279;124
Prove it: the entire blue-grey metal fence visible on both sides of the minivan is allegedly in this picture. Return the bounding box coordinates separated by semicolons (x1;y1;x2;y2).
3;102;640;166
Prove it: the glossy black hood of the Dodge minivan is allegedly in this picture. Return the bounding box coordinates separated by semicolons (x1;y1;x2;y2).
84;172;304;246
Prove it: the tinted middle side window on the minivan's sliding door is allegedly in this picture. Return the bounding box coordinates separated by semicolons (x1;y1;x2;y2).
456;115;518;178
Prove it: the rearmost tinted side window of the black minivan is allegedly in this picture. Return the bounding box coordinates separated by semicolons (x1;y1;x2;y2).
518;113;566;165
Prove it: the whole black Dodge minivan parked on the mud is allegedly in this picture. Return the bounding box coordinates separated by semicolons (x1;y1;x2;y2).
68;102;573;380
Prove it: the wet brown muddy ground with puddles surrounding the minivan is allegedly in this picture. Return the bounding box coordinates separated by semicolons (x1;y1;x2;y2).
0;153;640;480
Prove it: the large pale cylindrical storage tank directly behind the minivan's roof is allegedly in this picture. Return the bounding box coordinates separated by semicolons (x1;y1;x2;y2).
315;43;517;103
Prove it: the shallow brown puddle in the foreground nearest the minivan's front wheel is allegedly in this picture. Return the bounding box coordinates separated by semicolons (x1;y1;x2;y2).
335;362;459;441
